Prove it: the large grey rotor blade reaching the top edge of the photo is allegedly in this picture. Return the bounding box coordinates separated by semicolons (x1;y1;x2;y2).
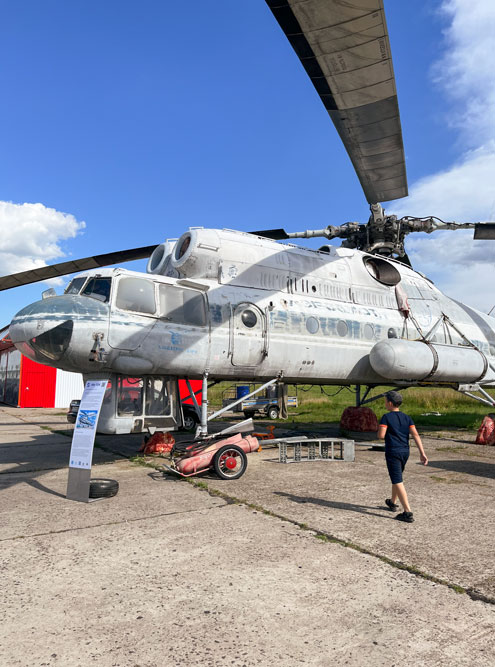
266;0;407;204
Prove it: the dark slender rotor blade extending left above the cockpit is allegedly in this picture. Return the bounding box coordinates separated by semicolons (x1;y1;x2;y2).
0;245;156;292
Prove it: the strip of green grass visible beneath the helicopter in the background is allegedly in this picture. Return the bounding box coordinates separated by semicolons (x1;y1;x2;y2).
209;382;495;431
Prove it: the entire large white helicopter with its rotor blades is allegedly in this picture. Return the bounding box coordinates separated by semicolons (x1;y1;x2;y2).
0;0;495;435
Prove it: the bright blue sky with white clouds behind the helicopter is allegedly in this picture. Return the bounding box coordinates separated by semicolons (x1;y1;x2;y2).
0;0;495;325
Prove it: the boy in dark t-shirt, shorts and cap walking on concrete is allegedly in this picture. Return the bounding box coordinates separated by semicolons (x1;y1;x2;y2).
378;391;428;523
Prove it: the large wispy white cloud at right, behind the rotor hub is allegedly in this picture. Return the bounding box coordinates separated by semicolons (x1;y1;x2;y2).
389;0;495;312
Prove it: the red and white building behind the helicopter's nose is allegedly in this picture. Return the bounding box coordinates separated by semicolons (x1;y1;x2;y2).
0;327;84;408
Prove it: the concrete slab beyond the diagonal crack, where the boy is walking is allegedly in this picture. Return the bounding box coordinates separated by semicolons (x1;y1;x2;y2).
202;438;495;599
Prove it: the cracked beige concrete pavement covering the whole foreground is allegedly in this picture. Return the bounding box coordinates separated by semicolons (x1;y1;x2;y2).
0;408;495;667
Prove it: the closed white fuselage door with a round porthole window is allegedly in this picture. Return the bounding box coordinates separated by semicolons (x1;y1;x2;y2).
232;303;266;366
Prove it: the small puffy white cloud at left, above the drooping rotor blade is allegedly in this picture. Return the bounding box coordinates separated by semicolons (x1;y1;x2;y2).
0;201;85;275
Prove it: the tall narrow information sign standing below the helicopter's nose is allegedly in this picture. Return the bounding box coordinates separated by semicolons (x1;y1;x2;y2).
66;380;108;503
